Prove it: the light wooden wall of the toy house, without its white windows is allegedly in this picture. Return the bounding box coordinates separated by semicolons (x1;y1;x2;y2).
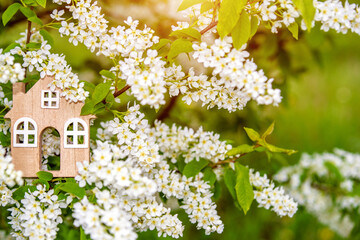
5;77;95;177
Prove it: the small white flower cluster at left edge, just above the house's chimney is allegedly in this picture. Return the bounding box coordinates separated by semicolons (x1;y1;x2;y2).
0;49;25;83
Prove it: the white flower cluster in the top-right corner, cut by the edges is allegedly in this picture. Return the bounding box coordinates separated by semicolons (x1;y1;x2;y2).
314;0;360;34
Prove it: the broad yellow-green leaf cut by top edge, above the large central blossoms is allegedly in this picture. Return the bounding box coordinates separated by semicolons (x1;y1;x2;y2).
217;0;247;38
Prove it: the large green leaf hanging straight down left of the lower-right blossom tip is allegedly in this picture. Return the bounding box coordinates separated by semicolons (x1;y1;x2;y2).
235;163;254;214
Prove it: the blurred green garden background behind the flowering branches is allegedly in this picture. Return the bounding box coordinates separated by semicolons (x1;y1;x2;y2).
0;0;360;240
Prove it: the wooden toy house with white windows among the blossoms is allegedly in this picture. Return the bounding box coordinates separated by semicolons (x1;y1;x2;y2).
5;77;95;177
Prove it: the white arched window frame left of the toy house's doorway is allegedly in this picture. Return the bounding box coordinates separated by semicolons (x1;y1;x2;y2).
13;117;38;147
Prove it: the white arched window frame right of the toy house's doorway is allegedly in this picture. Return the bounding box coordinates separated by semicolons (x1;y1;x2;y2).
64;118;89;148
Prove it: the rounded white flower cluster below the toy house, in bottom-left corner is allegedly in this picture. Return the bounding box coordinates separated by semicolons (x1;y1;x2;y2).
9;184;67;240
